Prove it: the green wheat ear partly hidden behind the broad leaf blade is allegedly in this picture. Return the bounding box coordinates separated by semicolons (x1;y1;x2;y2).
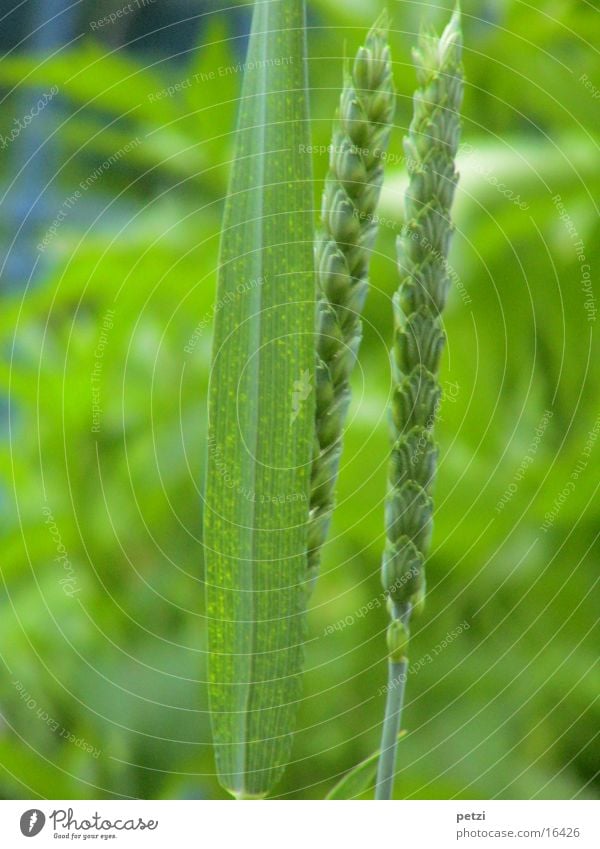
308;14;395;587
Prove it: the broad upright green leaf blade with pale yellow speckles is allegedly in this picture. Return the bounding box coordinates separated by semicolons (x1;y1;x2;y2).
204;0;315;797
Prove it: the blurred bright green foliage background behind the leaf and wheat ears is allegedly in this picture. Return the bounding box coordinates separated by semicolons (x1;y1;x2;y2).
0;0;600;799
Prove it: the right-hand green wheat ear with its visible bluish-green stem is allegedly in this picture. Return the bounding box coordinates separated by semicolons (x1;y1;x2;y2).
377;9;463;799
